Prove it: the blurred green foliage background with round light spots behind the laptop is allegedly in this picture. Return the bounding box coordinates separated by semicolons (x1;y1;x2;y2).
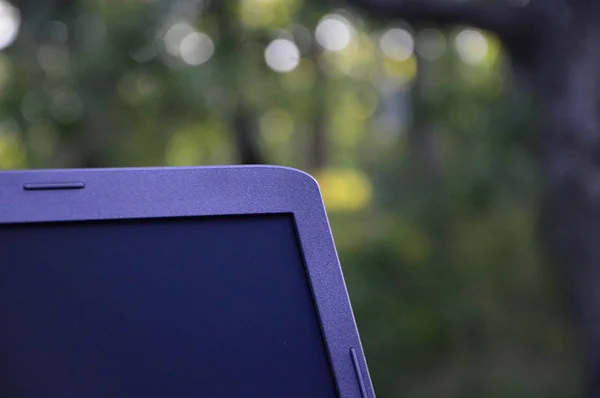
0;0;581;398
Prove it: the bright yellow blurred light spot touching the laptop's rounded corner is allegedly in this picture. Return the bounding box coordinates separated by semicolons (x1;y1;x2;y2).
315;169;373;212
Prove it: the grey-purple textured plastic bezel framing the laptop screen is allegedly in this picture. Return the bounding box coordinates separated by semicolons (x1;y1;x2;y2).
0;166;374;398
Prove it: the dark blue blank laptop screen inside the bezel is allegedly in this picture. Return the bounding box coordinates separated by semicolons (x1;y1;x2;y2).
0;215;337;398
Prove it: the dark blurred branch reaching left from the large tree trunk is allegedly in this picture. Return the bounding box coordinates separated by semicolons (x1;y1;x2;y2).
347;0;521;38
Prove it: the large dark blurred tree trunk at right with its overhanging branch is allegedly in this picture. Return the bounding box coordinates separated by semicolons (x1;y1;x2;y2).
348;0;600;397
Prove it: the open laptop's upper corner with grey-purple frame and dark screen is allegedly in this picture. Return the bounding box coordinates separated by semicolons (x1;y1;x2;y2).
0;166;374;398
